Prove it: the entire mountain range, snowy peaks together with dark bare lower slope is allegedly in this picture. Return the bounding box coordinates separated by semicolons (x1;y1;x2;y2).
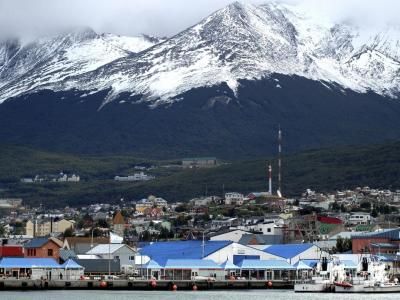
0;3;400;158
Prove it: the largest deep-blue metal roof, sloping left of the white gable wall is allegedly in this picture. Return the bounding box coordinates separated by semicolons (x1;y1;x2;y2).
140;241;232;264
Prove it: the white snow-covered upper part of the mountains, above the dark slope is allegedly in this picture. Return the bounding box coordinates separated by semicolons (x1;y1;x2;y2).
0;2;400;105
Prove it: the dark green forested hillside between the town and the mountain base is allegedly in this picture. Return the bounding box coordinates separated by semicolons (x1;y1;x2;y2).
0;142;400;207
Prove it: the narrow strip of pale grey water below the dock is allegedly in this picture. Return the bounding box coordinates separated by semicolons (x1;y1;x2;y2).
0;290;400;300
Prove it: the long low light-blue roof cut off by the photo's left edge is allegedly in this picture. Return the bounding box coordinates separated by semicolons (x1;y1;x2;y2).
0;257;62;269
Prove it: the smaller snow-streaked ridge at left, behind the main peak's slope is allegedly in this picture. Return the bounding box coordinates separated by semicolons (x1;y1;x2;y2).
0;28;160;99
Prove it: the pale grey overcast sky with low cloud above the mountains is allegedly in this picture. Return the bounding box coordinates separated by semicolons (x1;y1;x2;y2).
0;0;400;37
